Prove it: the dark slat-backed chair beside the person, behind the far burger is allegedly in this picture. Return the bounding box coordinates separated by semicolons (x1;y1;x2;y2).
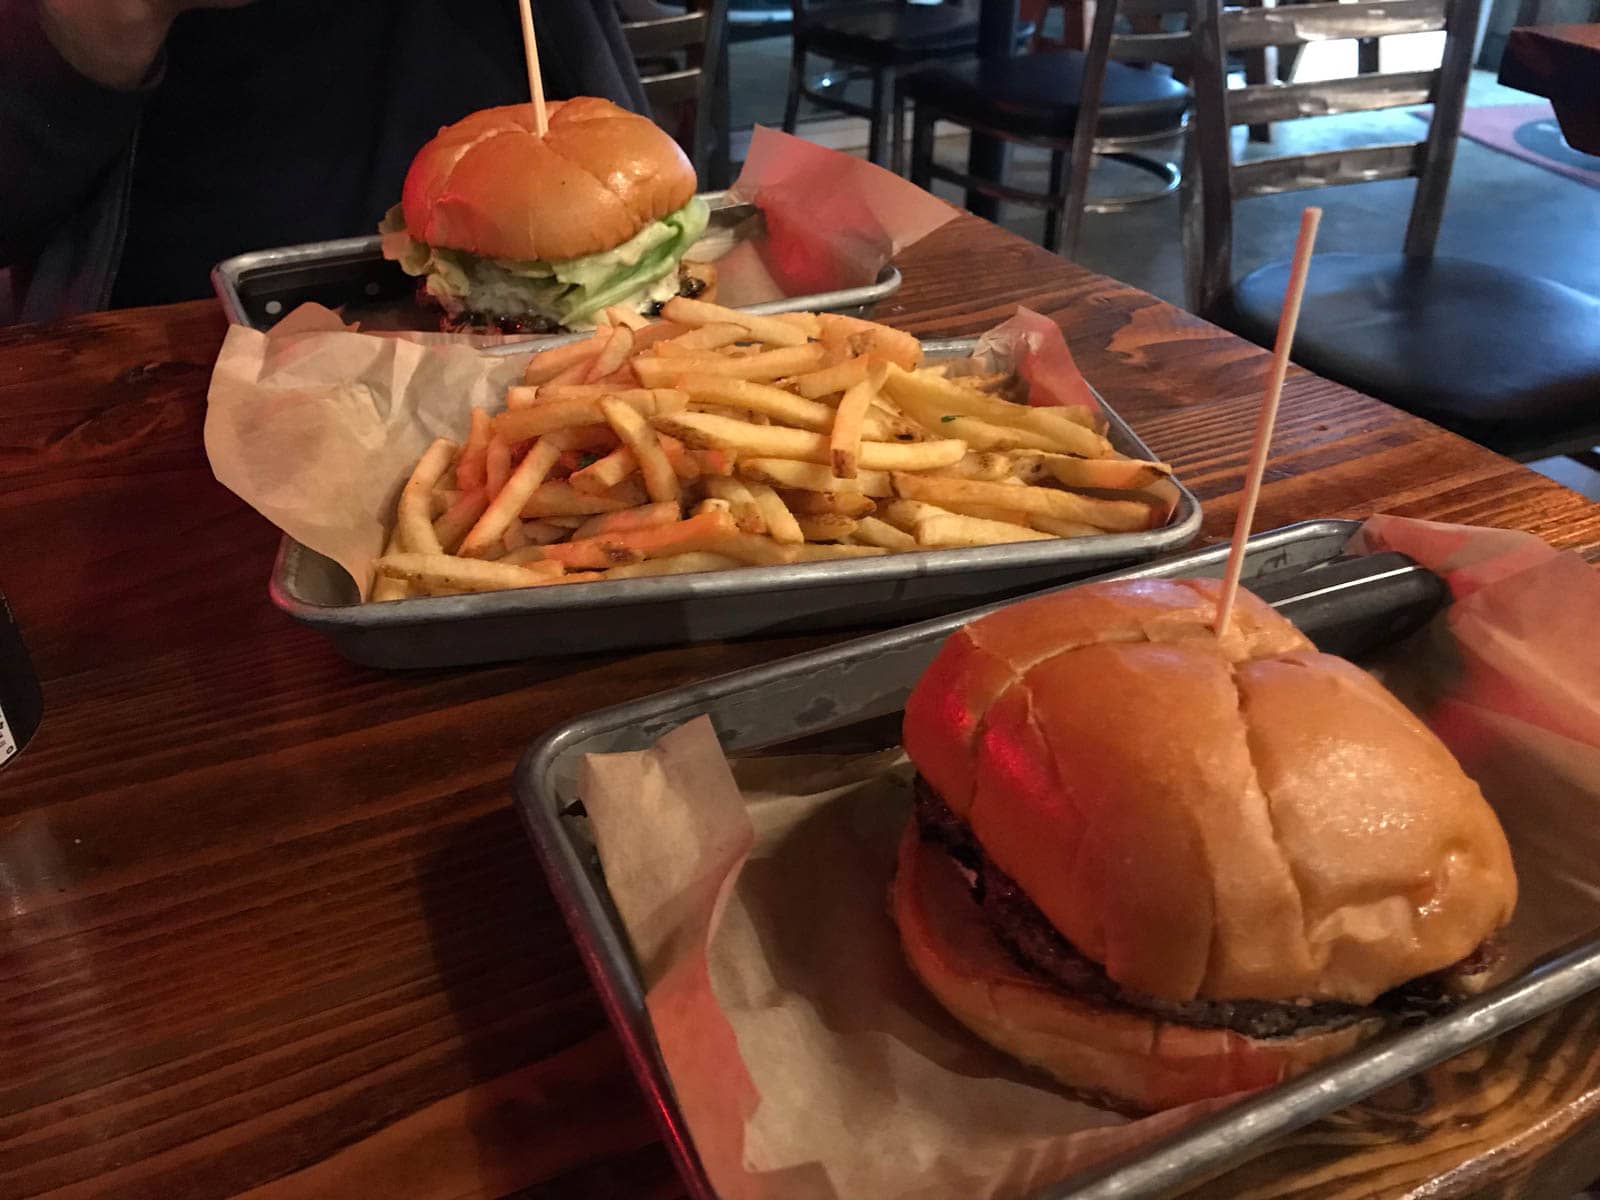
622;0;731;189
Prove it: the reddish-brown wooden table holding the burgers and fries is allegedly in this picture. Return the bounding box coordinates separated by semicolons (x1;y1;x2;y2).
9;216;1600;1200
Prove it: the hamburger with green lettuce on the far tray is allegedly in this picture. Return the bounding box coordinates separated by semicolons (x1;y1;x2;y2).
379;96;715;333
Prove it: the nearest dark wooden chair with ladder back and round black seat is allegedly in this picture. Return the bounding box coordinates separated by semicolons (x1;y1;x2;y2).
1184;0;1600;459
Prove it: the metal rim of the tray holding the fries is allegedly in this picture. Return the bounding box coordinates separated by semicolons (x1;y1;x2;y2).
267;338;1203;629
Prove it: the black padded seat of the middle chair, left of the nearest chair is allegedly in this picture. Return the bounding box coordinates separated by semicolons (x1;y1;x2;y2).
906;50;1189;139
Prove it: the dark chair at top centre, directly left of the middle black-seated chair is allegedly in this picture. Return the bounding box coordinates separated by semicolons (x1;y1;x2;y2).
784;0;1034;171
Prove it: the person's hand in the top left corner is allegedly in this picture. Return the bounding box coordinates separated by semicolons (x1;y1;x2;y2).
38;0;253;88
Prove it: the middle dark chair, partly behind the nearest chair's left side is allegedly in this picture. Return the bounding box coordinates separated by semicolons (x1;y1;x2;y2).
899;0;1192;254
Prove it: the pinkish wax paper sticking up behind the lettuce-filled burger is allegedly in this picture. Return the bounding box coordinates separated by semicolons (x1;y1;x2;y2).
730;126;955;302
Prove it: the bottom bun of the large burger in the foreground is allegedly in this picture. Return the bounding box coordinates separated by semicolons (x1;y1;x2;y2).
890;821;1382;1112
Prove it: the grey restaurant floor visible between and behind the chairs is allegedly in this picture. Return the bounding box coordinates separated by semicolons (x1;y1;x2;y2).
733;35;1600;499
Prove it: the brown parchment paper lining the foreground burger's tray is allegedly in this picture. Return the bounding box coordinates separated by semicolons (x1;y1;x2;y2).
581;517;1600;1200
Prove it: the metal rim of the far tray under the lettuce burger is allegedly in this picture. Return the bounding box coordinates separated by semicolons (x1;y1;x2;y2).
211;190;904;339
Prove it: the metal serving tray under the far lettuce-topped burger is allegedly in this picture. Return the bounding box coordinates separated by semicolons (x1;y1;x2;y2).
211;192;901;336
